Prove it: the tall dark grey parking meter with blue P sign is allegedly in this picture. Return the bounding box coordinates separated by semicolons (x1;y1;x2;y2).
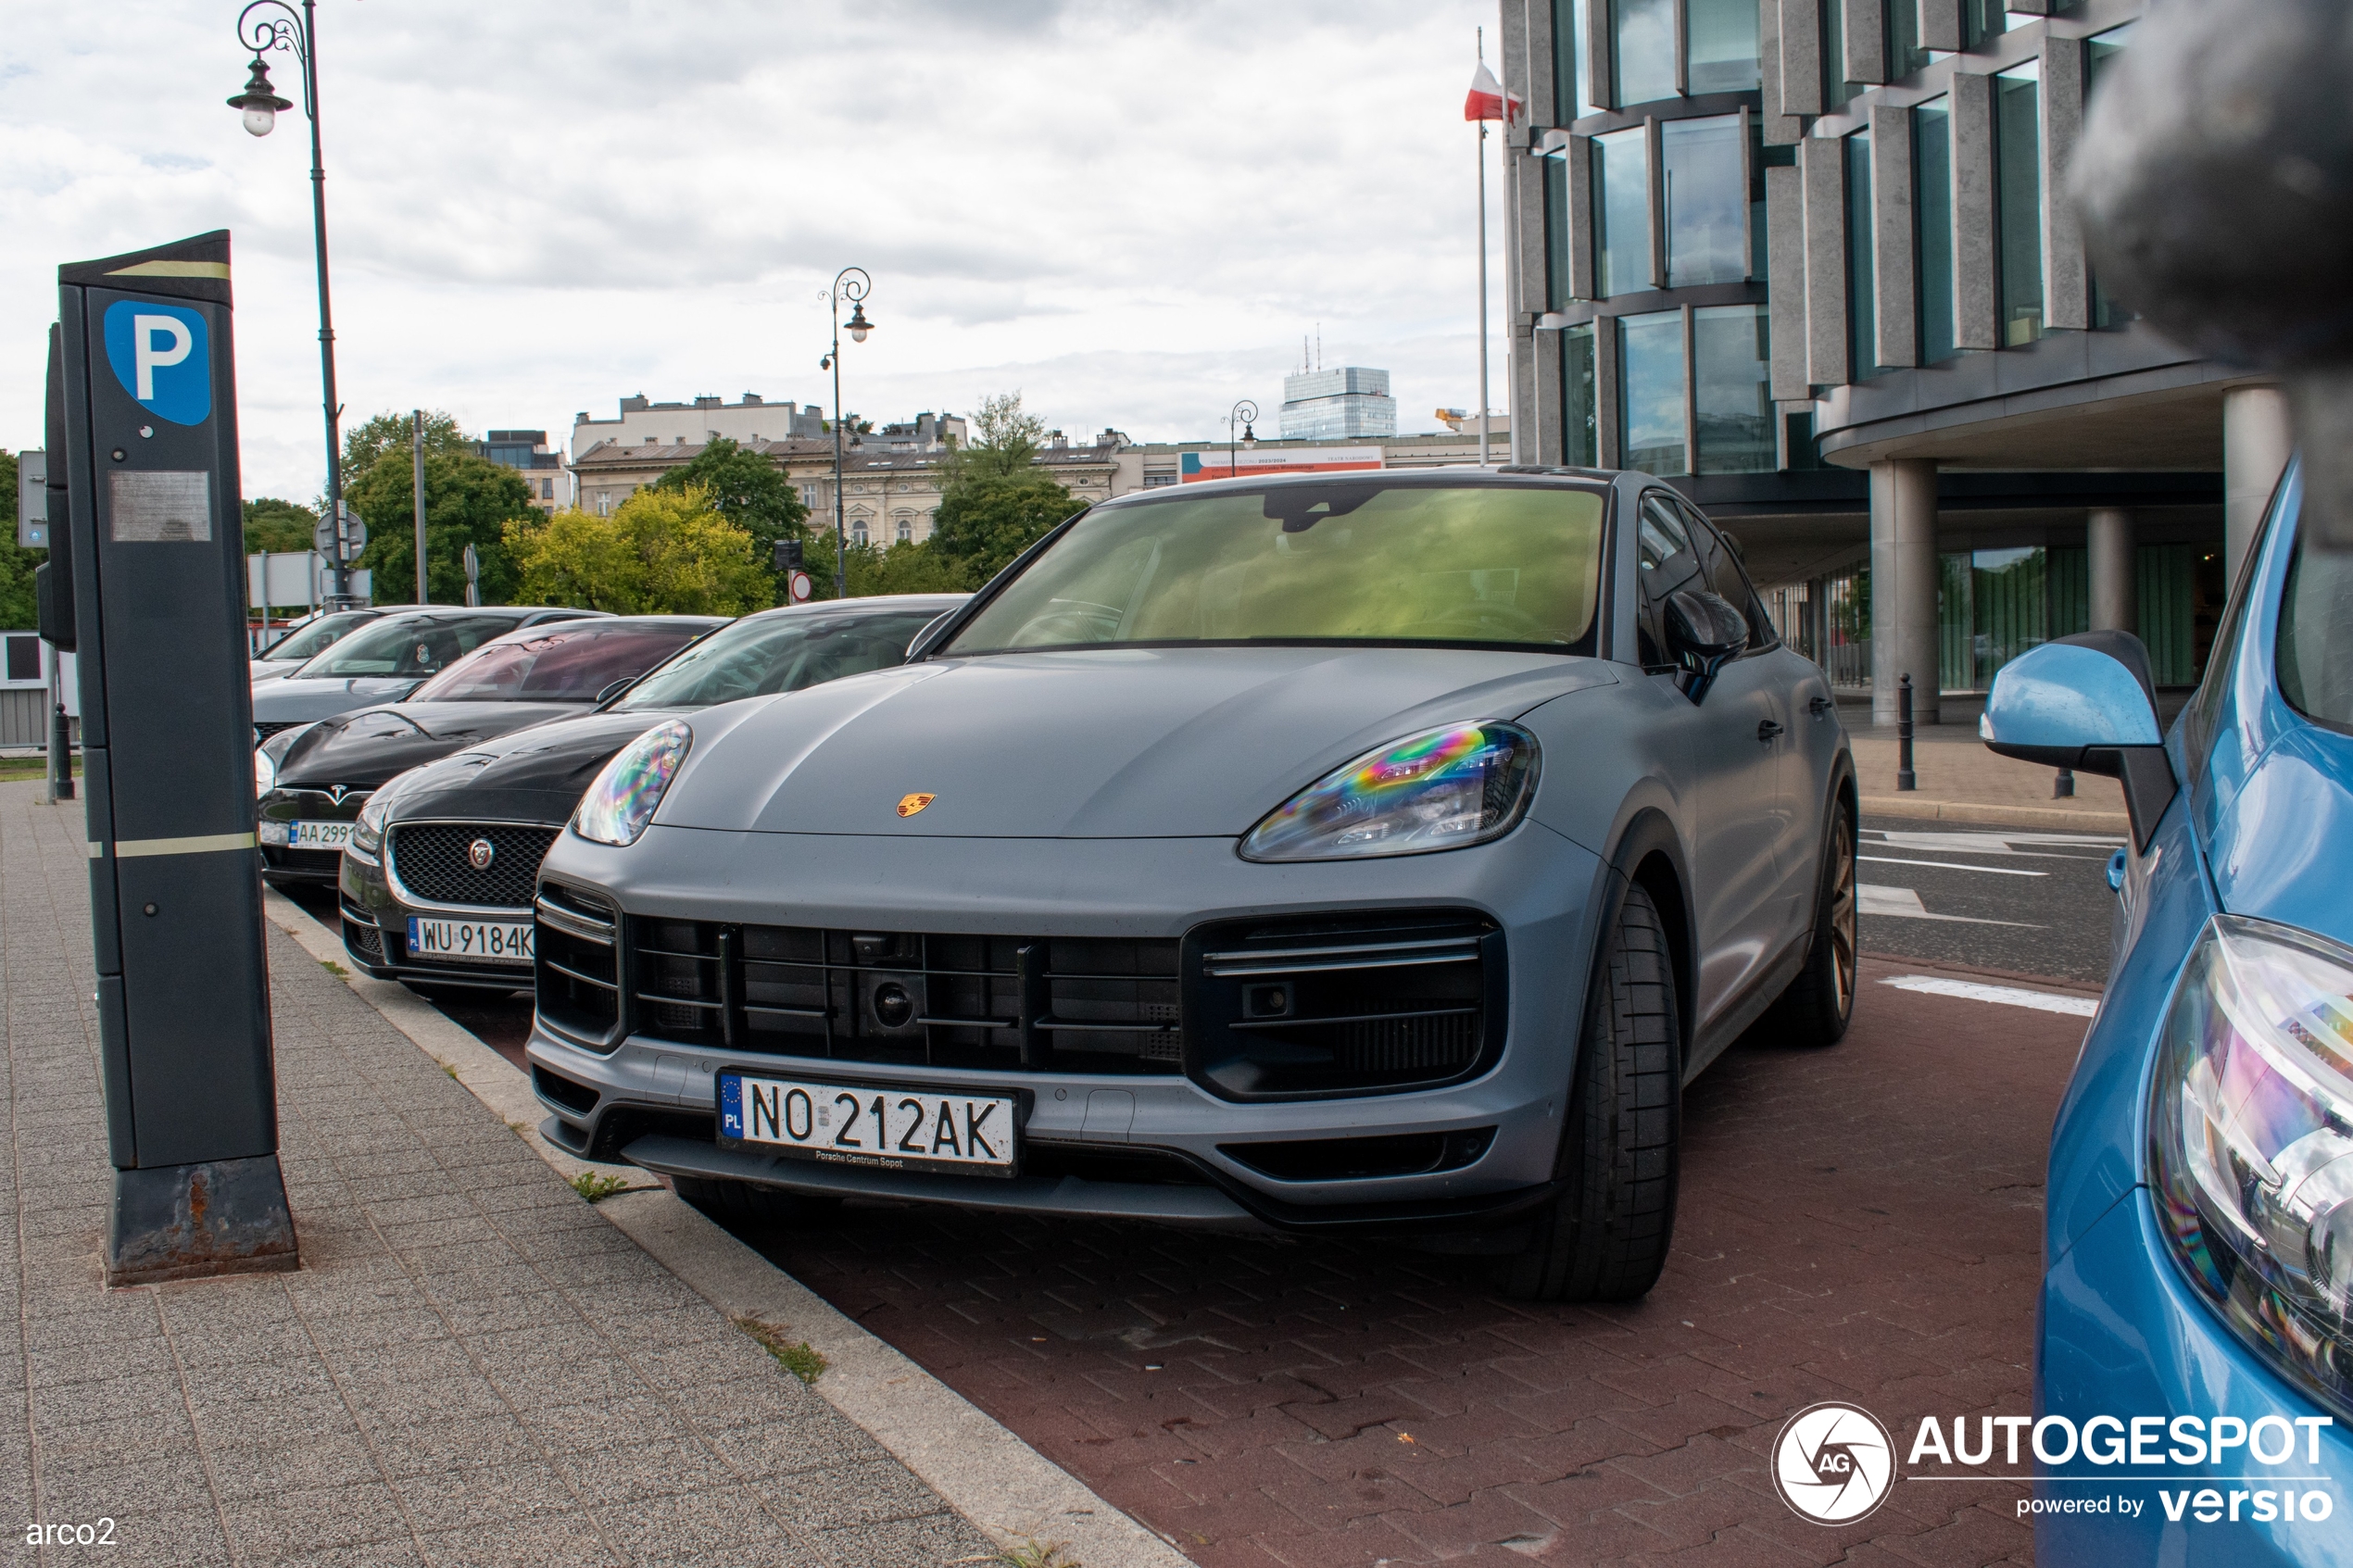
49;231;296;1284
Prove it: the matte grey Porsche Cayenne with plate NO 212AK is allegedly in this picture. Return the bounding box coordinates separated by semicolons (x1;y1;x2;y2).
530;468;1856;1300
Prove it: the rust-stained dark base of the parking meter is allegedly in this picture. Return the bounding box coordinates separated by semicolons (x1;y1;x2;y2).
106;1154;301;1286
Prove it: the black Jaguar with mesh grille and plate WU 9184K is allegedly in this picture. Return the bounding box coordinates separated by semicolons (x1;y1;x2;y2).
341;595;964;995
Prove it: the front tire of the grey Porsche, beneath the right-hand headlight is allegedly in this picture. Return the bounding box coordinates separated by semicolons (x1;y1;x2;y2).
1496;886;1682;1302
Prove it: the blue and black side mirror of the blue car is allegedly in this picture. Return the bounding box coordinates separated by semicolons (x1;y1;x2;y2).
1977;633;2177;848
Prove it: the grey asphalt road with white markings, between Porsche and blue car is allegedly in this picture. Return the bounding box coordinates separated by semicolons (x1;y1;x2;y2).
1856;818;2125;985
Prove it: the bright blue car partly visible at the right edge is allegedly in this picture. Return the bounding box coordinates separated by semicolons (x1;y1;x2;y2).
1982;466;2353;1568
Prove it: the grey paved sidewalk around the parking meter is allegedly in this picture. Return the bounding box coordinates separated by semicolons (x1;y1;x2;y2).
0;783;990;1568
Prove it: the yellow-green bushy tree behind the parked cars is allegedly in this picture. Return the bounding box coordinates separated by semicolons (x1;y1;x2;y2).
506;486;774;616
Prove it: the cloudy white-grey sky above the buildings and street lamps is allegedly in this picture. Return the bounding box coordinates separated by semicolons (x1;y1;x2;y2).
0;0;1504;496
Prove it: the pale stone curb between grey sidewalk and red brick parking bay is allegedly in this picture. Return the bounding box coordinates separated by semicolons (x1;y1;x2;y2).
263;888;1189;1568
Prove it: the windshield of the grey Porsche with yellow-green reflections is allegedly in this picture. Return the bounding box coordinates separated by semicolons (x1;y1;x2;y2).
946;480;1604;654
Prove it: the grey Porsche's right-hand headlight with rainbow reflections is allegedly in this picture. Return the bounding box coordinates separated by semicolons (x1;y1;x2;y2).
1242;721;1537;860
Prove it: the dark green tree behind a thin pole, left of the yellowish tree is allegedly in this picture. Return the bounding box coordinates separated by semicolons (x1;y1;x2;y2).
344;453;539;604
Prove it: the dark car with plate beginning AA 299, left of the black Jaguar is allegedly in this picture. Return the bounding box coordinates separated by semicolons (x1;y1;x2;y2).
254;616;724;886
